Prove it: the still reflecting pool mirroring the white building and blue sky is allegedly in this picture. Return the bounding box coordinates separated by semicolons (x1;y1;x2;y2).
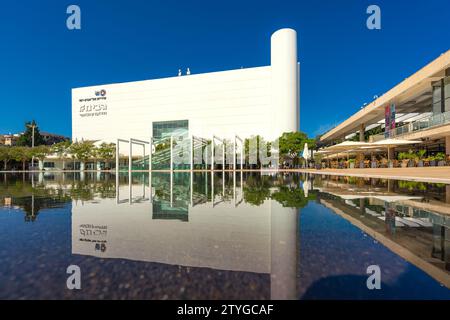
0;172;450;299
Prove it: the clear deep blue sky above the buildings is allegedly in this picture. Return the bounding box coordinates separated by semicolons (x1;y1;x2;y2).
0;0;450;136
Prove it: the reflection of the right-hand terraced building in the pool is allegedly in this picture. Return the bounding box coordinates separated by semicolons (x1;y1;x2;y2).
315;176;450;286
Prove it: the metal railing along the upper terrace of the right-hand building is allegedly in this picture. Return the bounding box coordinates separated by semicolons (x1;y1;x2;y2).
370;111;450;142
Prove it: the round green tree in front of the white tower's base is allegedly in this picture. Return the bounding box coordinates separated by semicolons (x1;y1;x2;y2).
279;131;316;166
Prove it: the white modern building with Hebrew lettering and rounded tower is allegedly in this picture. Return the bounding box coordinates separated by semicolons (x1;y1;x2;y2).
72;29;300;142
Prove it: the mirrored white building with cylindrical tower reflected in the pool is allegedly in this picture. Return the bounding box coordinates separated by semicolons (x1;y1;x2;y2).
72;173;299;299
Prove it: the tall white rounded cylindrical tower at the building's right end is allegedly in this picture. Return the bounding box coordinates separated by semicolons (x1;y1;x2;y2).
270;29;300;137
